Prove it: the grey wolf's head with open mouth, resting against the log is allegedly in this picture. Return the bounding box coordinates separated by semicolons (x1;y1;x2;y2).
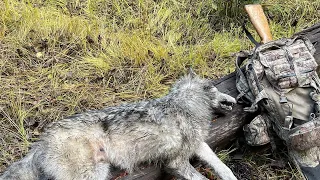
172;69;236;112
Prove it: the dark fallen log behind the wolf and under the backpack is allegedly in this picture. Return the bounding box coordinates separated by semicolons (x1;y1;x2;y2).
114;23;320;180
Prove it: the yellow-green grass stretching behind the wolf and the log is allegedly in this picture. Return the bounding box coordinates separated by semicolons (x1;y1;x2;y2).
0;0;320;178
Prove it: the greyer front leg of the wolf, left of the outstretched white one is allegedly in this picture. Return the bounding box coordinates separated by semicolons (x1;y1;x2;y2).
167;159;208;180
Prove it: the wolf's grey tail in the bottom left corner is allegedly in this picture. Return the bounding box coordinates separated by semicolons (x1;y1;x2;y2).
0;151;39;180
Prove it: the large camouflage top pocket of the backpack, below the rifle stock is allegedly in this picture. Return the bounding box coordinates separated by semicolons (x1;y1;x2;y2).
258;38;318;92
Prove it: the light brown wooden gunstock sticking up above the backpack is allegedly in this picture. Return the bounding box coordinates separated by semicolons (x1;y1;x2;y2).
244;4;272;43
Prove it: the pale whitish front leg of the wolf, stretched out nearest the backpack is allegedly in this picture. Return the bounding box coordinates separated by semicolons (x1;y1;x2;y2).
196;142;237;180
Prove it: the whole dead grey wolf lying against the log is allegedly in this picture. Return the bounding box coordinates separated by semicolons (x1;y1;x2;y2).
0;73;236;180
